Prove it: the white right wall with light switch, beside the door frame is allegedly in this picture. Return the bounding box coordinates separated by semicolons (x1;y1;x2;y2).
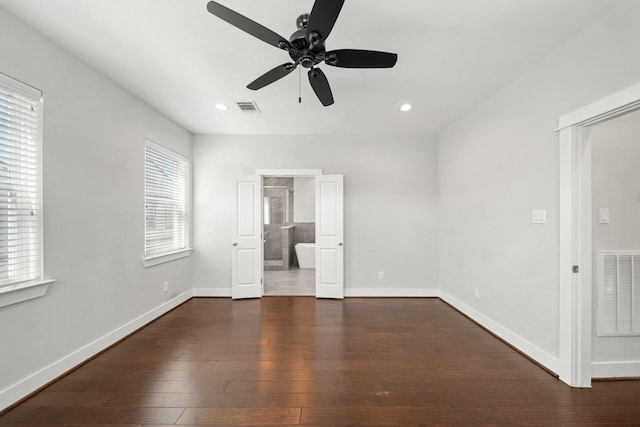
438;0;640;369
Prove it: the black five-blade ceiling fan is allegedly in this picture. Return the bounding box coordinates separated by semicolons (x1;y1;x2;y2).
207;0;398;107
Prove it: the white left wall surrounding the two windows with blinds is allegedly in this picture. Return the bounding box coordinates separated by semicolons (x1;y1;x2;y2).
0;9;191;409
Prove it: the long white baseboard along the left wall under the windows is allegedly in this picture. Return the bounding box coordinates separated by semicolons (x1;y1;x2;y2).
0;290;193;411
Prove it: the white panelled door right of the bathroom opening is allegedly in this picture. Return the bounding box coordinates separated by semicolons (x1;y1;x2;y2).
316;175;344;299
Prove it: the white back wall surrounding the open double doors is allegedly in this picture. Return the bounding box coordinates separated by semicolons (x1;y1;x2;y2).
193;135;437;295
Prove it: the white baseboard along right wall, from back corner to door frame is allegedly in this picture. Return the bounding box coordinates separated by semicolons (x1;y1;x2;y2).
439;290;560;373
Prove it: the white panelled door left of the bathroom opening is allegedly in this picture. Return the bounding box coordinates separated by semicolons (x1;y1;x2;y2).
231;175;262;299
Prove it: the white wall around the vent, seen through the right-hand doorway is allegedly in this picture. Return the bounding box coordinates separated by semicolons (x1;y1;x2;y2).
591;111;640;376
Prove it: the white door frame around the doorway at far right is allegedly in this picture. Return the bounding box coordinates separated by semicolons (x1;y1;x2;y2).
556;79;640;387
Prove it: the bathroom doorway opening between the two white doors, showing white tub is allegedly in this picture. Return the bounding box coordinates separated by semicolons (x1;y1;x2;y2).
262;176;316;296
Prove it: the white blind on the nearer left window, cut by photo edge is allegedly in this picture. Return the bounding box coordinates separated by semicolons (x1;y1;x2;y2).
0;73;42;287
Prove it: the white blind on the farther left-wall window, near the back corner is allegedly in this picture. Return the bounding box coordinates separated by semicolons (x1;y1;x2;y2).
144;140;188;258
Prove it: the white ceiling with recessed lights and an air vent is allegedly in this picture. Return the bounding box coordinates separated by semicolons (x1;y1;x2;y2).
0;0;619;135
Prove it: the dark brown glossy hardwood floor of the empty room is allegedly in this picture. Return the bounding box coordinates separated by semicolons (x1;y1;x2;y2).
0;297;640;427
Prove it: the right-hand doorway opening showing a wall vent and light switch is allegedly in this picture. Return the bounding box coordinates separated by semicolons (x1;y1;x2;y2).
590;110;640;378
